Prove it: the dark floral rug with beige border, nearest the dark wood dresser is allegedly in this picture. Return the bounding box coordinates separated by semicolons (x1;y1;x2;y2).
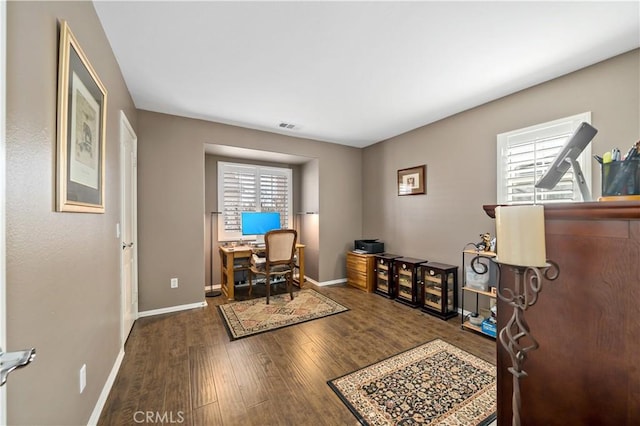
327;339;497;426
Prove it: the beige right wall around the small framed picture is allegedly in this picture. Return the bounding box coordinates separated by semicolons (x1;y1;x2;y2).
363;50;640;302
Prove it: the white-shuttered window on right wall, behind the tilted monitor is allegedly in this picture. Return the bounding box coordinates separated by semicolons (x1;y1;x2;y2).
497;112;591;204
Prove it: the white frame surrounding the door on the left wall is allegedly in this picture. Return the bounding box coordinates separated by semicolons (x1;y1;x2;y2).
118;110;138;348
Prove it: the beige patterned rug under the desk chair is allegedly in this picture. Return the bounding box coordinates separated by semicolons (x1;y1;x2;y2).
218;289;348;340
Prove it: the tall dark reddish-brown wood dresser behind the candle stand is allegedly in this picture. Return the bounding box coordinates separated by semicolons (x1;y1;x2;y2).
484;201;640;426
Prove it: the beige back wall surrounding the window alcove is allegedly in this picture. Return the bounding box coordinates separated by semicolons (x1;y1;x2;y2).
138;111;362;311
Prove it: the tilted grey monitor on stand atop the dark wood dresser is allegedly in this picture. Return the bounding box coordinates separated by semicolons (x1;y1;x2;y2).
536;122;598;201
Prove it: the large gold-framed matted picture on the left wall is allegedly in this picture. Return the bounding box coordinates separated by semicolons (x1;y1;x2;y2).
56;21;107;213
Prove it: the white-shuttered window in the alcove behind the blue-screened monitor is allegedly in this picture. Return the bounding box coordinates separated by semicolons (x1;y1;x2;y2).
218;161;293;241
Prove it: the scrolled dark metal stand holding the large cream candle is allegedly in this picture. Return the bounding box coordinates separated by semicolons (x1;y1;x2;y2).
497;260;560;426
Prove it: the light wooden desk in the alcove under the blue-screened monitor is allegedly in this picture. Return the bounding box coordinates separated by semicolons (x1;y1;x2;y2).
219;244;305;300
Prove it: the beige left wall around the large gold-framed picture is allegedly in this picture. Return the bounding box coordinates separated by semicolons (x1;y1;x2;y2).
6;2;137;425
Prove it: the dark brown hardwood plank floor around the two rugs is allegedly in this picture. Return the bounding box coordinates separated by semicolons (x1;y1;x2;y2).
99;283;496;426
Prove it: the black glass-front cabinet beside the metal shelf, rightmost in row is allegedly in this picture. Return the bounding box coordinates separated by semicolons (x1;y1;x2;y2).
420;262;458;320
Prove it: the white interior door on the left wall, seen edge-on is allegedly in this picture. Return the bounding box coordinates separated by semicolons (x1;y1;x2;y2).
120;111;138;345
